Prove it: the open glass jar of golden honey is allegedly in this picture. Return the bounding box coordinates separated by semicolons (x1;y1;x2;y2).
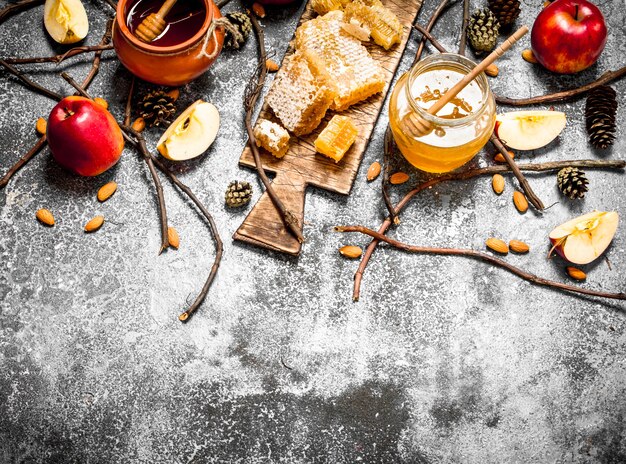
389;53;496;173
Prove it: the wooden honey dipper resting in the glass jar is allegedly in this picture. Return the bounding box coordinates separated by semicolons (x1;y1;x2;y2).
405;26;528;137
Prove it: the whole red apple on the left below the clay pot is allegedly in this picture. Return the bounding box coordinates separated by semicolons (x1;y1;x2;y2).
46;96;124;176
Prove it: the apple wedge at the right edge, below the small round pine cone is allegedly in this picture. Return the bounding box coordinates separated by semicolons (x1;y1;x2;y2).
550;211;619;264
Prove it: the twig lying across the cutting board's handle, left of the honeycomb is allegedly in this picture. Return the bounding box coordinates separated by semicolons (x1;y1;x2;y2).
244;13;304;243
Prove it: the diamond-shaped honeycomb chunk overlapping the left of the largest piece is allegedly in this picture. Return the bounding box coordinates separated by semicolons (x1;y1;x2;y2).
266;50;337;136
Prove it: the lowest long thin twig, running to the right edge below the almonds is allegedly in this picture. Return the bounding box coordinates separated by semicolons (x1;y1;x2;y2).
335;226;626;300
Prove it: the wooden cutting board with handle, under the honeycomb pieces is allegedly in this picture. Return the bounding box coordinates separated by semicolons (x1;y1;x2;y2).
233;0;422;255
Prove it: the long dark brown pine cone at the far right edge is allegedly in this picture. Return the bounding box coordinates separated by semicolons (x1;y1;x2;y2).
585;85;617;148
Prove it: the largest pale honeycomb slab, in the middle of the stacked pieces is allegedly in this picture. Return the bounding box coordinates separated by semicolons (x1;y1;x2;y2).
296;11;385;111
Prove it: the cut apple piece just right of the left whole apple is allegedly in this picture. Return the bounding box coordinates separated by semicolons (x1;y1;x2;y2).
157;100;220;161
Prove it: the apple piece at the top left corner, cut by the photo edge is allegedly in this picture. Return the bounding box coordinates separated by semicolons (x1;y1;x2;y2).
43;0;89;44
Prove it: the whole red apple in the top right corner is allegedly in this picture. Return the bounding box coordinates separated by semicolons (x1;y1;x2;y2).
530;0;607;74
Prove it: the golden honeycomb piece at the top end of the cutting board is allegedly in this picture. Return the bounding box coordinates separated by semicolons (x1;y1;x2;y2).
345;0;403;50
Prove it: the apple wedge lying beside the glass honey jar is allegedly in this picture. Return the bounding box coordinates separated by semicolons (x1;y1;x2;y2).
496;111;566;150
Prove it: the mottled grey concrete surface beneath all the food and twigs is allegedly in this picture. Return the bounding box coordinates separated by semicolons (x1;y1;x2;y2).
0;0;626;463
